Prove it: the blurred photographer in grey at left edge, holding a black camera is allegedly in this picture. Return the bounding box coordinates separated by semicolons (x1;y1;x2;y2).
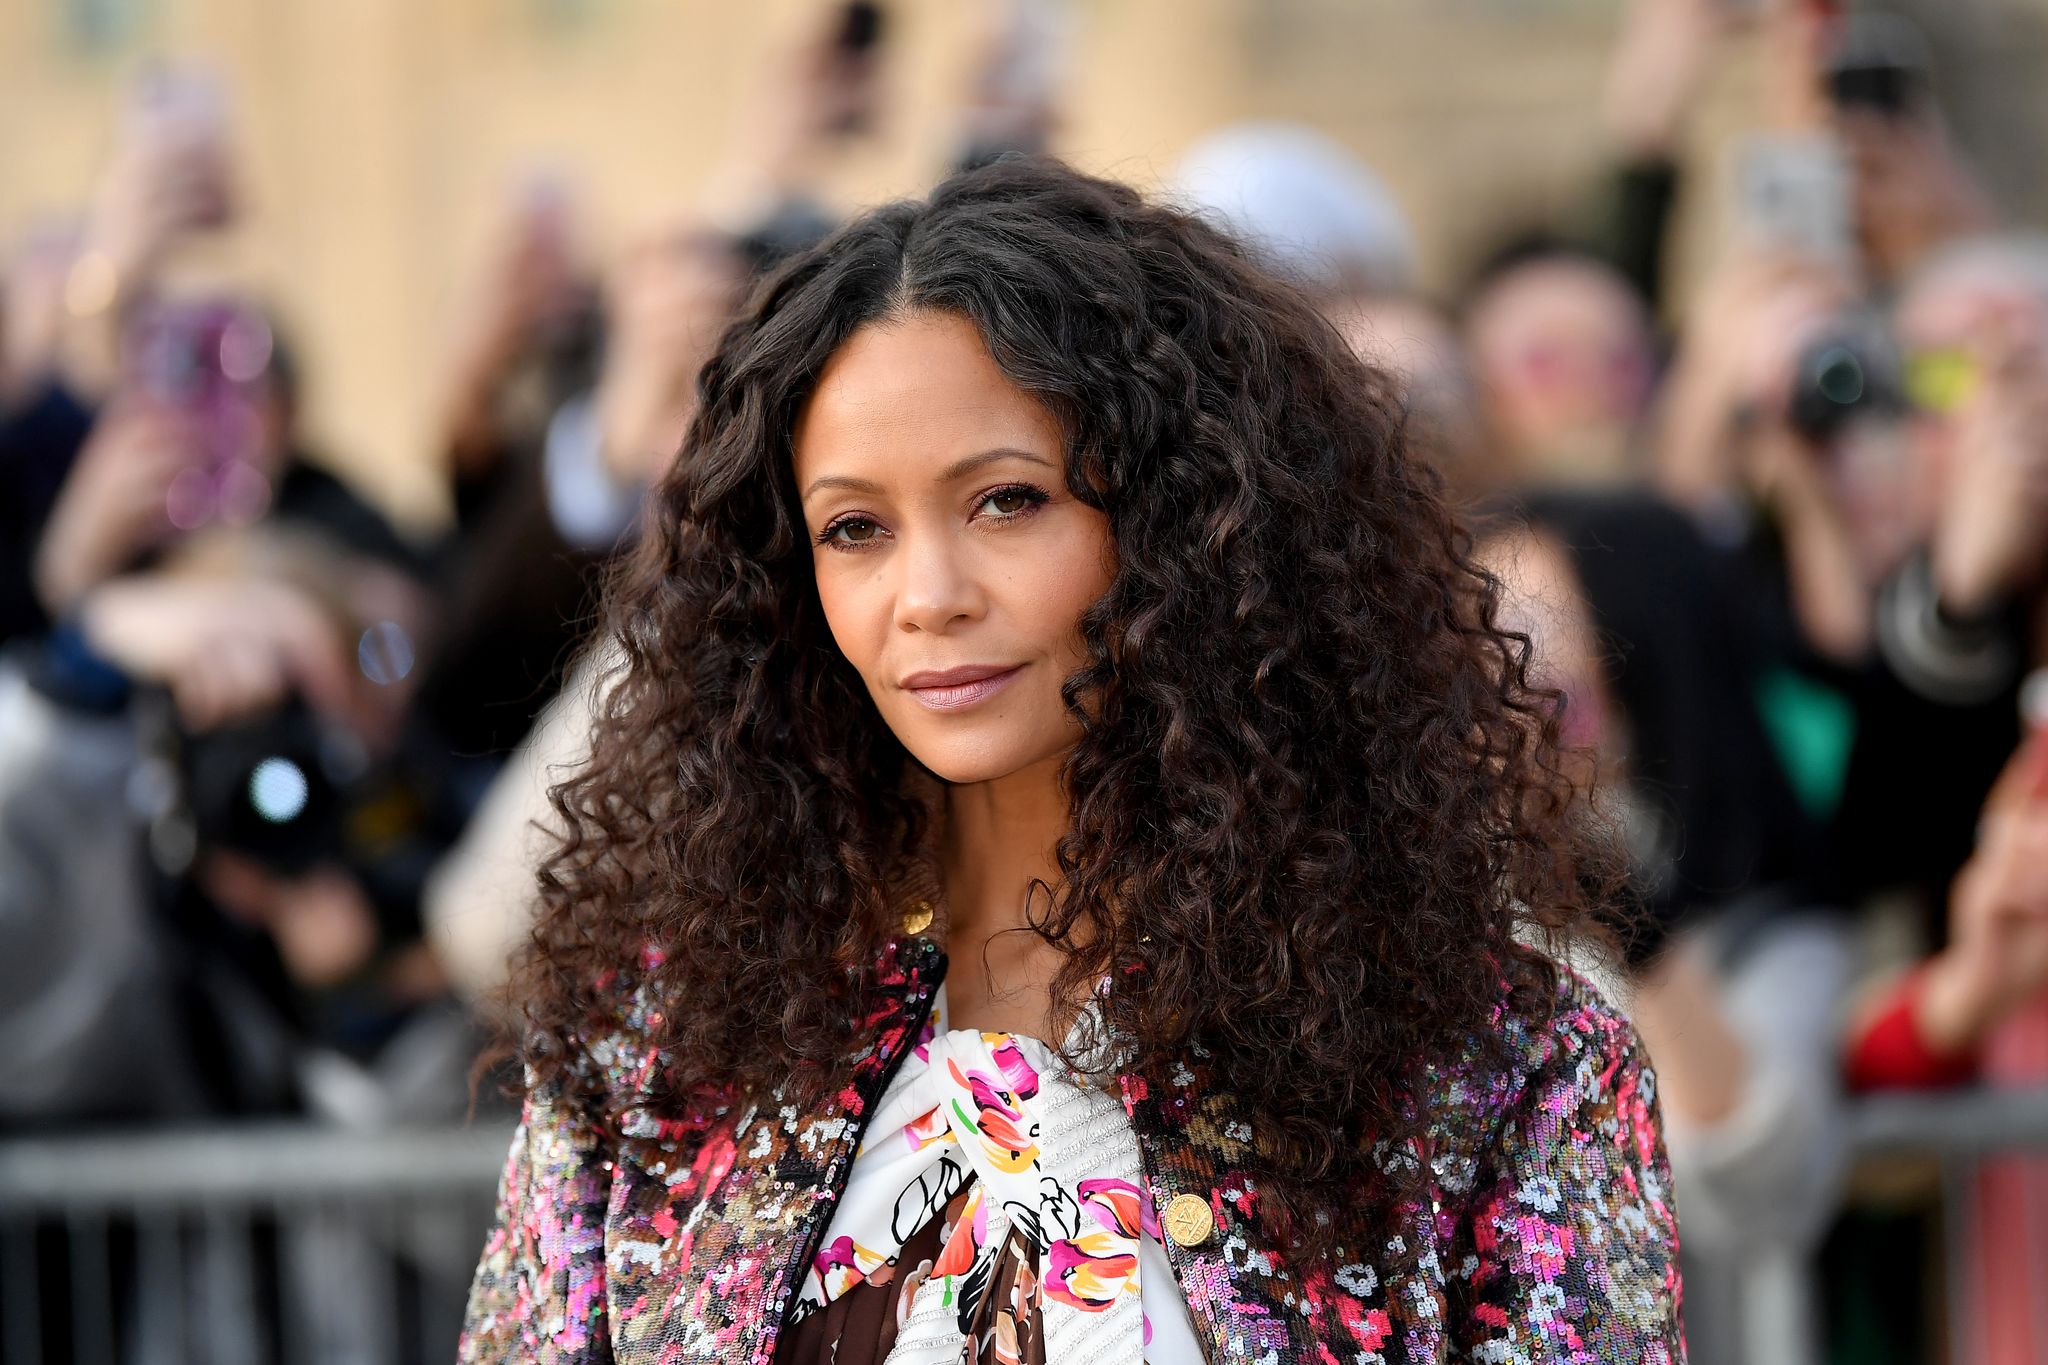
0;518;440;1124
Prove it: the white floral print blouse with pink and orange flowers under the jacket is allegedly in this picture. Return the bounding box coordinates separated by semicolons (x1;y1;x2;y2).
776;986;1202;1365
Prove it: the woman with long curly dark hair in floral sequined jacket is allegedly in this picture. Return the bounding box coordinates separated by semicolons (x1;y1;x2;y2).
463;162;1681;1365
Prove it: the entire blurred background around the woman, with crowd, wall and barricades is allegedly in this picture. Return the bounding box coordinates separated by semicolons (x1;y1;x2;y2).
0;0;2048;1365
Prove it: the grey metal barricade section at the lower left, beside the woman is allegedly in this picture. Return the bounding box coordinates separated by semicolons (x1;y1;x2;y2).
0;1124;510;1365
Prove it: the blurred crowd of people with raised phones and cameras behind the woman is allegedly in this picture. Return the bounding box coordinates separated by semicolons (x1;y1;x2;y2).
0;0;2048;1361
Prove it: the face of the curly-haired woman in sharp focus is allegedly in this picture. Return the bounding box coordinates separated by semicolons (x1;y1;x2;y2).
795;313;1114;782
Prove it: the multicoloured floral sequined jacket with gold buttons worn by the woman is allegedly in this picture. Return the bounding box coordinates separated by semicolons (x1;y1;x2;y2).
461;939;1683;1365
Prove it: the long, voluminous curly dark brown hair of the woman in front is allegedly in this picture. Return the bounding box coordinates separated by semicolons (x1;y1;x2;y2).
518;160;1612;1252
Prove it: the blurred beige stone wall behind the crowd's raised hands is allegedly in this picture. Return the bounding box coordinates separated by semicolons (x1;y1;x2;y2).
0;0;2019;520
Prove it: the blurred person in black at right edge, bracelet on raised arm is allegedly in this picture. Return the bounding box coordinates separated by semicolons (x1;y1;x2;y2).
1845;235;2048;907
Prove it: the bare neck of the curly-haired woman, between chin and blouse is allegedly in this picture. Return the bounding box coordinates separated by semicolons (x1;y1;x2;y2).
938;755;1067;1042
